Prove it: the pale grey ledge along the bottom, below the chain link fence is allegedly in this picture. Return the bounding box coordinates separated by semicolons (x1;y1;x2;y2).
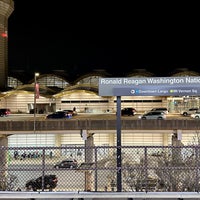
0;192;200;200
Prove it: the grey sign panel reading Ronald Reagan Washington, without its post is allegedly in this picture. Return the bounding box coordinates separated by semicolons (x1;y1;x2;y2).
99;76;200;96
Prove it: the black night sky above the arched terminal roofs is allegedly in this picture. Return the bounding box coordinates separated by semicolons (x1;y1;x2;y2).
8;0;200;76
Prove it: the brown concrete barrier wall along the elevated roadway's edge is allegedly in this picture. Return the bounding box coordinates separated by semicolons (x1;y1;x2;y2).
0;119;200;131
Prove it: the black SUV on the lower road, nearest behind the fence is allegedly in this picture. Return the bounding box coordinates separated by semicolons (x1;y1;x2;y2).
25;174;58;191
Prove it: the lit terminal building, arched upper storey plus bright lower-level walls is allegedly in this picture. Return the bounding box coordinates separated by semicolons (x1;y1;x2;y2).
0;70;199;150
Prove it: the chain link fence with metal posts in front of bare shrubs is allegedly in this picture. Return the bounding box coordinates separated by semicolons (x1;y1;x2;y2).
0;146;200;192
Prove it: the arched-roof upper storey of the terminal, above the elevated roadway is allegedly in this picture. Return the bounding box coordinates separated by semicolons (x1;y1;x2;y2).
0;70;199;113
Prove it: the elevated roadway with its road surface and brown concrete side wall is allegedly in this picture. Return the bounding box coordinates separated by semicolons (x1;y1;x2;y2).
0;114;200;134
